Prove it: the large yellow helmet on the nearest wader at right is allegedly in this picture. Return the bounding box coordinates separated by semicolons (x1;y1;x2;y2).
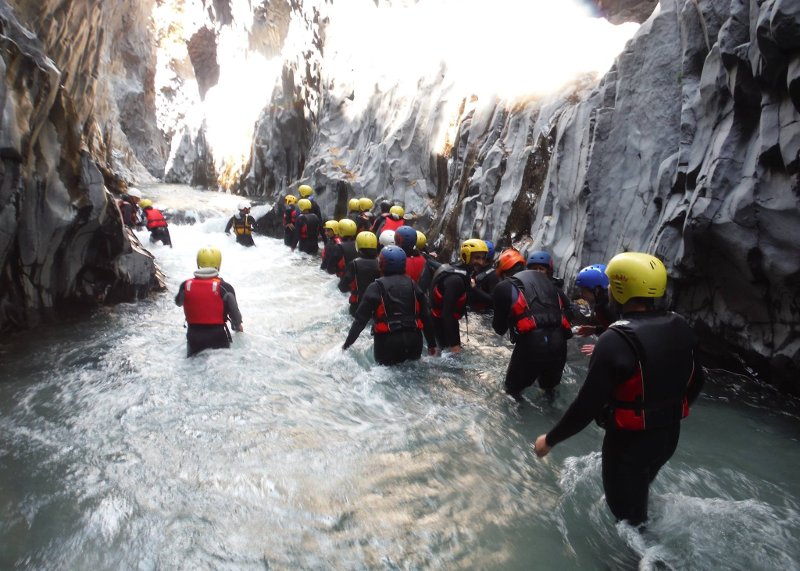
606;252;667;303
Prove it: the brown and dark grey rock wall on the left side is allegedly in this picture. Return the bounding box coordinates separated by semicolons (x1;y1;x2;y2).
0;2;158;331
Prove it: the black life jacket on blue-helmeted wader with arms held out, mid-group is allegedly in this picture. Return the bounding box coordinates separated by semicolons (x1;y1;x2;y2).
372;274;422;335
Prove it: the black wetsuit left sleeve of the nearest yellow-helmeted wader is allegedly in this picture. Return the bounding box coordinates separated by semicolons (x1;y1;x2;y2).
546;331;636;446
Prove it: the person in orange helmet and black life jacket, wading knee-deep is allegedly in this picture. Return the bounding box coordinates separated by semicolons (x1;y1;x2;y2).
492;248;572;401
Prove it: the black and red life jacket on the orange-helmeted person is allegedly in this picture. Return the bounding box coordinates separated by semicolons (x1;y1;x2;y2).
508;270;570;335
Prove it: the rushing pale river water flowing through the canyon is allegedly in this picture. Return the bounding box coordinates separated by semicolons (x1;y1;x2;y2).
0;187;800;570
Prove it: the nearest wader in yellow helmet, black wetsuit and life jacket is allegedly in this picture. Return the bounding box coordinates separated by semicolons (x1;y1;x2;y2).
535;252;704;525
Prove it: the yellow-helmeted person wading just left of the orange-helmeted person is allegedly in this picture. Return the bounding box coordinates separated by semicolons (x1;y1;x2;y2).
430;238;489;353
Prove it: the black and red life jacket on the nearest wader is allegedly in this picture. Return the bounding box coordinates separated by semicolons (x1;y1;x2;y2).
604;312;695;430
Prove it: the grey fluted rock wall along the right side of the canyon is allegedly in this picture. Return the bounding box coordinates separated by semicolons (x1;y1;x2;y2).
241;0;800;392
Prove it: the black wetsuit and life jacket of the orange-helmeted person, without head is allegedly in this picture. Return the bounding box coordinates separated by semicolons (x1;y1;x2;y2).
492;270;571;399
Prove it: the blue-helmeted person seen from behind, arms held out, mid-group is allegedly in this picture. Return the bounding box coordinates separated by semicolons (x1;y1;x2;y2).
342;246;436;365
